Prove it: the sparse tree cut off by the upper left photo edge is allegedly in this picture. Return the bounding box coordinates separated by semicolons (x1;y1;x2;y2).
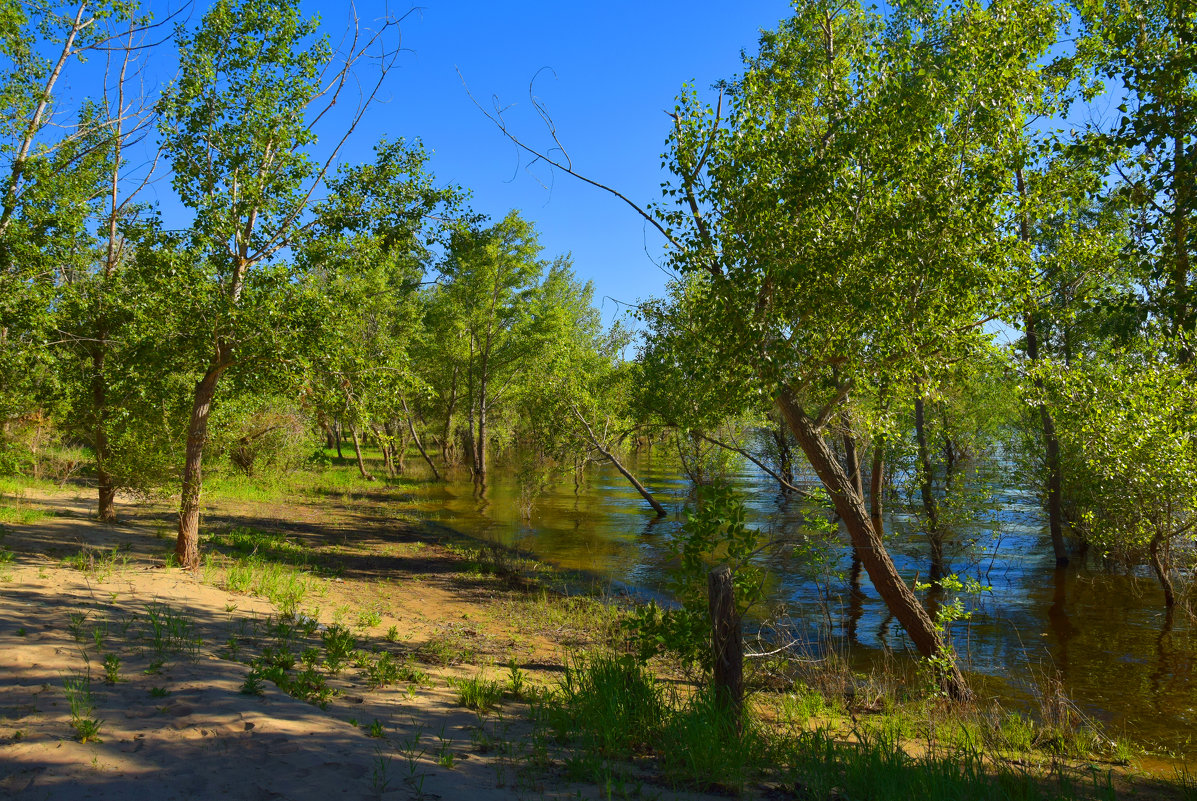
0;2;145;474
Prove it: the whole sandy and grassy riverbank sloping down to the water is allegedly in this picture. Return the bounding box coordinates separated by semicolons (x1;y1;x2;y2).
0;469;1191;799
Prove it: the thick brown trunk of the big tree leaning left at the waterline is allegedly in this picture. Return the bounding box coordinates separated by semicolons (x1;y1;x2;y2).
777;388;972;699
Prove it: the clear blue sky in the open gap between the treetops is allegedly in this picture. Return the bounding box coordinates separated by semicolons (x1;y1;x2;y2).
306;0;790;322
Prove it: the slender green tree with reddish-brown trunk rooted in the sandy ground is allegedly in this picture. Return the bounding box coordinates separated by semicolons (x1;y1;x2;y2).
158;0;391;568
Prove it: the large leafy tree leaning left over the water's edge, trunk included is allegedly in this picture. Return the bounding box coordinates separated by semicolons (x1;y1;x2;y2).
662;2;1059;697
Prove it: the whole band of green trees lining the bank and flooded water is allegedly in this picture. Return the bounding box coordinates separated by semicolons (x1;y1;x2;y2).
0;0;1197;696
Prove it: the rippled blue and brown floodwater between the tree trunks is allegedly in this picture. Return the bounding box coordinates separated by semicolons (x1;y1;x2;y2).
404;456;1197;758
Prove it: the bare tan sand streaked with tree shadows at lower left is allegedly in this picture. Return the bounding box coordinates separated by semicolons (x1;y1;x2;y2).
0;488;708;801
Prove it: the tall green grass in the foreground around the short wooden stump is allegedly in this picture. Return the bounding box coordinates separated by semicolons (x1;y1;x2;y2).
531;654;1116;801
